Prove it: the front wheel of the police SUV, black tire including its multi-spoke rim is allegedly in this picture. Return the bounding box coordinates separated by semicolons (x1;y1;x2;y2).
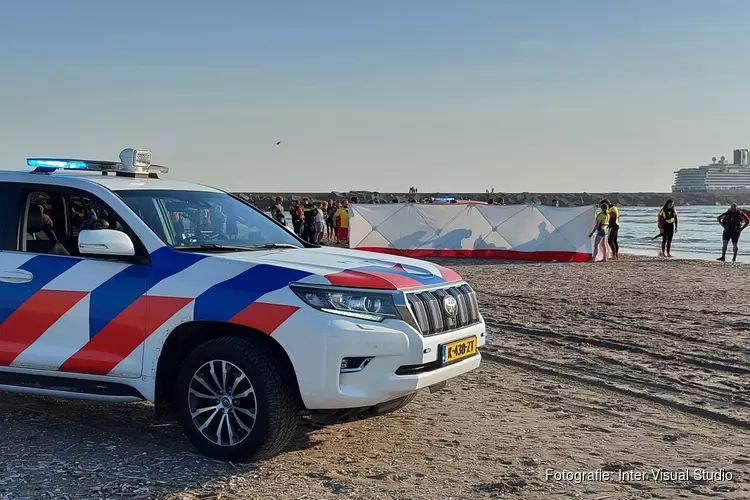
175;337;300;462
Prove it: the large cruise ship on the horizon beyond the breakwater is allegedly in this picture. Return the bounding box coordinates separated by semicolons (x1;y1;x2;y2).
672;149;750;193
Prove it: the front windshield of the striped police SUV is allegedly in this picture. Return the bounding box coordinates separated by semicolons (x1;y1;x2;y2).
117;189;303;250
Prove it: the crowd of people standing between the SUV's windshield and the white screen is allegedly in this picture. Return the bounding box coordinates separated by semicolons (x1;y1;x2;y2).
271;196;359;247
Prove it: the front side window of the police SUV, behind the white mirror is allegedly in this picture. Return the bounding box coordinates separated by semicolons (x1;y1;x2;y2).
18;190;135;256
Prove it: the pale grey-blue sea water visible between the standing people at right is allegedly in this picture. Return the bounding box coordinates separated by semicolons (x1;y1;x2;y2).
268;206;750;263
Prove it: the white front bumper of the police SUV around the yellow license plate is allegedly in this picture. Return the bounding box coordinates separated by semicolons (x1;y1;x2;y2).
273;307;487;410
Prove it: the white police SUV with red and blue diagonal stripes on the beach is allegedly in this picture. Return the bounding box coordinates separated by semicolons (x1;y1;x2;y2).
0;148;486;460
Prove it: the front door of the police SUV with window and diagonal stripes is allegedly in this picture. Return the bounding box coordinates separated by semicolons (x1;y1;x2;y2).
0;184;148;378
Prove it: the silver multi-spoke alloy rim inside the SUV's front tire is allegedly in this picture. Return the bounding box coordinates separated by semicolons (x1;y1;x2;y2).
188;360;258;446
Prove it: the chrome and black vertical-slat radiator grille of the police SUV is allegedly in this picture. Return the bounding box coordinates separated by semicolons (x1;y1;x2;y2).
407;285;480;336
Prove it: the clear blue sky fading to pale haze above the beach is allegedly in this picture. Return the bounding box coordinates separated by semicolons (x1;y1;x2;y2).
0;0;750;193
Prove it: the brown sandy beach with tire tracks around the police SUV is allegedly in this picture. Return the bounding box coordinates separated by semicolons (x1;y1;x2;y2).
0;258;750;500
